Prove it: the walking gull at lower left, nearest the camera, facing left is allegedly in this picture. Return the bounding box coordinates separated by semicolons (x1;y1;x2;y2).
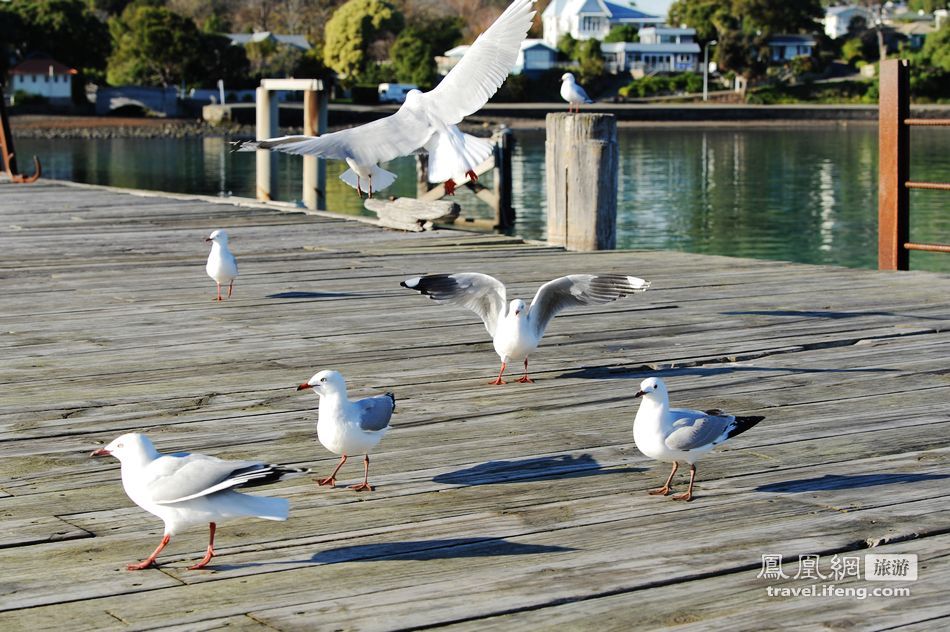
90;432;308;571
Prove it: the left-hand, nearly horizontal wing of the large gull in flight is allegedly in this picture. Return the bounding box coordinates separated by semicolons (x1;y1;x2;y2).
237;107;432;165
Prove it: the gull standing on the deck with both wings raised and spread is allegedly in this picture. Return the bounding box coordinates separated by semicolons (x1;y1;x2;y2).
400;272;650;385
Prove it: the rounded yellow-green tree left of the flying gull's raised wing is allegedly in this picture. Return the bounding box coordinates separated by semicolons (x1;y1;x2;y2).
323;0;404;80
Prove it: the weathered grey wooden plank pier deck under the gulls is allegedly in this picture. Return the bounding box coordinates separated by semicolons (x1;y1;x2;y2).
0;181;950;631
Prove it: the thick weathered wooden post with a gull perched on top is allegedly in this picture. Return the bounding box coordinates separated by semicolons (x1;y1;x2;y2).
545;113;619;250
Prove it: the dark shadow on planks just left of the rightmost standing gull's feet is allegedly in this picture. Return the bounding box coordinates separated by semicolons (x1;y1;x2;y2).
432;454;645;486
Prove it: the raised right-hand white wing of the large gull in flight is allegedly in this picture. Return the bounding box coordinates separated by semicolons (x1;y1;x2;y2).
422;0;534;125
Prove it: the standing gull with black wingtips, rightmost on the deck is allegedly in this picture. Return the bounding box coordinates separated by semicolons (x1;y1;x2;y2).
633;377;765;501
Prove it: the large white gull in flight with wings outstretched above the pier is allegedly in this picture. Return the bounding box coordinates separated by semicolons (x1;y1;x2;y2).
235;0;534;197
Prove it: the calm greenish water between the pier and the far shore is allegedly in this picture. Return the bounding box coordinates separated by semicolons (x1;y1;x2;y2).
17;124;950;271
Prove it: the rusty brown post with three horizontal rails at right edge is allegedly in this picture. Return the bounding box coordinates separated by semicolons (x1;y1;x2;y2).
877;59;950;270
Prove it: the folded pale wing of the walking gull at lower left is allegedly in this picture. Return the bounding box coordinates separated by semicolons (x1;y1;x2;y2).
143;454;279;504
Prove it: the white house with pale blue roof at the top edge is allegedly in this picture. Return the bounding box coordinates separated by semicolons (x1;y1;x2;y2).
541;0;663;47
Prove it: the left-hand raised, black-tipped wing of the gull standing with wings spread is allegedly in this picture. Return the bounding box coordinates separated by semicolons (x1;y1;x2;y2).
400;272;506;337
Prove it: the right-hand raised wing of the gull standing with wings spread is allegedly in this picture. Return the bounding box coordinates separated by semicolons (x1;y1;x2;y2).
528;274;650;336
